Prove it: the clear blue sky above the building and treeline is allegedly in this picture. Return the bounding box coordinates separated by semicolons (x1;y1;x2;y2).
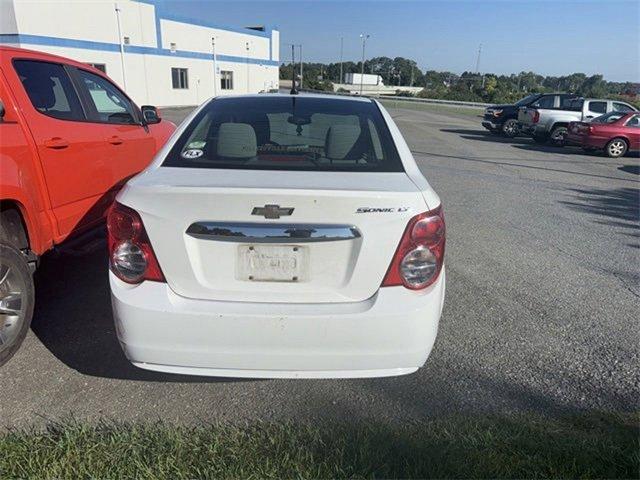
165;0;640;82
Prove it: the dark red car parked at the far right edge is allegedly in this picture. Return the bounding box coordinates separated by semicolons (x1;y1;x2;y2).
565;111;640;158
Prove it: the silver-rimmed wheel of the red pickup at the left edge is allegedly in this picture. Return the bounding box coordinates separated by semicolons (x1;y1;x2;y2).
0;243;35;366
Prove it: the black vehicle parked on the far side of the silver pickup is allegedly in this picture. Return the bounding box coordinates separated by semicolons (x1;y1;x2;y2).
482;93;577;138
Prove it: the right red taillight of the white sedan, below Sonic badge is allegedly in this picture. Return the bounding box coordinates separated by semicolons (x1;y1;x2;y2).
382;206;445;290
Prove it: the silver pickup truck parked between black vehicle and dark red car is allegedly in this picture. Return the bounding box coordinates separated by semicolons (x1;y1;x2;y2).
518;97;636;144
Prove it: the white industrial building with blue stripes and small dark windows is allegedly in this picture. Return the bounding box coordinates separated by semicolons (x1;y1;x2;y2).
0;0;280;106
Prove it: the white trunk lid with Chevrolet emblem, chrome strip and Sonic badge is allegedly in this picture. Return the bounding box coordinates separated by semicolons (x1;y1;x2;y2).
120;167;428;303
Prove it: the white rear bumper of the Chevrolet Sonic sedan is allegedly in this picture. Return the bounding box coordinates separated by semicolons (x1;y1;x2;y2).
109;270;445;378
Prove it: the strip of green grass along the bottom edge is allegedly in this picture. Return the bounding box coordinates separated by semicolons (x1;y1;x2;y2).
0;414;640;479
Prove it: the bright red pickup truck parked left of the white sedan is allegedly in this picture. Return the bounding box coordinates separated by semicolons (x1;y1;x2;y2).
0;47;175;365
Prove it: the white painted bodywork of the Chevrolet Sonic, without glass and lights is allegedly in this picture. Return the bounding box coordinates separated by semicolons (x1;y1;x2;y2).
110;95;444;378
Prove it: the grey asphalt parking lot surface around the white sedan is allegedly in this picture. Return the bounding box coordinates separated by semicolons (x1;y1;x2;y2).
0;103;640;426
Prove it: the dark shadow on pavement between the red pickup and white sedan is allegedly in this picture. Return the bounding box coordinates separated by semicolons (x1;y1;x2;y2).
31;239;249;383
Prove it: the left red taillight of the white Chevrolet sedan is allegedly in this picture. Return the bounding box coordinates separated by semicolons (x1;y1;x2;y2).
107;202;165;284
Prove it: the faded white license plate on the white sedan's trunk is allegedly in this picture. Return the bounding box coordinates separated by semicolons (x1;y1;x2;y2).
236;245;309;282
